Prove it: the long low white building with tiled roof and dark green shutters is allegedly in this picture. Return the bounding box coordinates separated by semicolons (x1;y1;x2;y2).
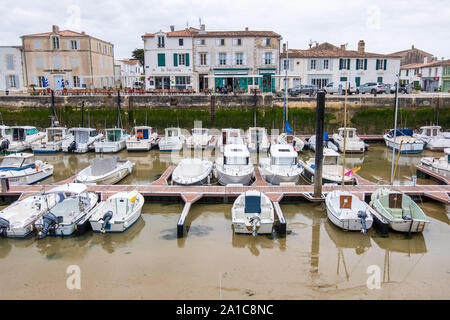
277;40;400;89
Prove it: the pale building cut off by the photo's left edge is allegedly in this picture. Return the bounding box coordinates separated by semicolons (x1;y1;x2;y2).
0;46;23;92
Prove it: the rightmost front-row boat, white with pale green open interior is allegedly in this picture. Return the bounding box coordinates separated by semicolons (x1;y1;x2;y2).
370;188;430;232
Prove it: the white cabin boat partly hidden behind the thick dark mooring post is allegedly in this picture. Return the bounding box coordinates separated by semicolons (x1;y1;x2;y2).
300;148;354;184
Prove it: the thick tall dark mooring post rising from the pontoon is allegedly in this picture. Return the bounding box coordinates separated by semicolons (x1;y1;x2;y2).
314;89;325;198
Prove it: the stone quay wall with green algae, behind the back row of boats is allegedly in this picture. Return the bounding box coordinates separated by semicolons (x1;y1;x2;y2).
0;95;450;134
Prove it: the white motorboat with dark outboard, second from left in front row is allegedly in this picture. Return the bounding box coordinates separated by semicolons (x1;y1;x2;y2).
35;183;98;239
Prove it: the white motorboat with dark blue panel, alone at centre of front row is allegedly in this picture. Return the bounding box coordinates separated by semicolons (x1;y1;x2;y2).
231;190;275;236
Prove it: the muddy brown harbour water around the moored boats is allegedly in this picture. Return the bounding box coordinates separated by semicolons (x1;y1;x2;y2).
0;145;450;299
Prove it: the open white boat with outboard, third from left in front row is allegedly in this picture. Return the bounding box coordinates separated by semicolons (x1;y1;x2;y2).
89;190;144;233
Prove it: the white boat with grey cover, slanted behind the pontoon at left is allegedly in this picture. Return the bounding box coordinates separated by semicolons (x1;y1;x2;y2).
75;157;134;184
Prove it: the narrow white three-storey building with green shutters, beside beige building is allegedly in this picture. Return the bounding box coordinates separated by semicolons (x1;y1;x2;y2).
142;27;197;91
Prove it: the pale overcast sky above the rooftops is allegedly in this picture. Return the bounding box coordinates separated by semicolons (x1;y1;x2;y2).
0;0;450;59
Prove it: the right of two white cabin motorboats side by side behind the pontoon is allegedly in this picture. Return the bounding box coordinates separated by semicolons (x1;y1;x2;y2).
259;144;303;185
